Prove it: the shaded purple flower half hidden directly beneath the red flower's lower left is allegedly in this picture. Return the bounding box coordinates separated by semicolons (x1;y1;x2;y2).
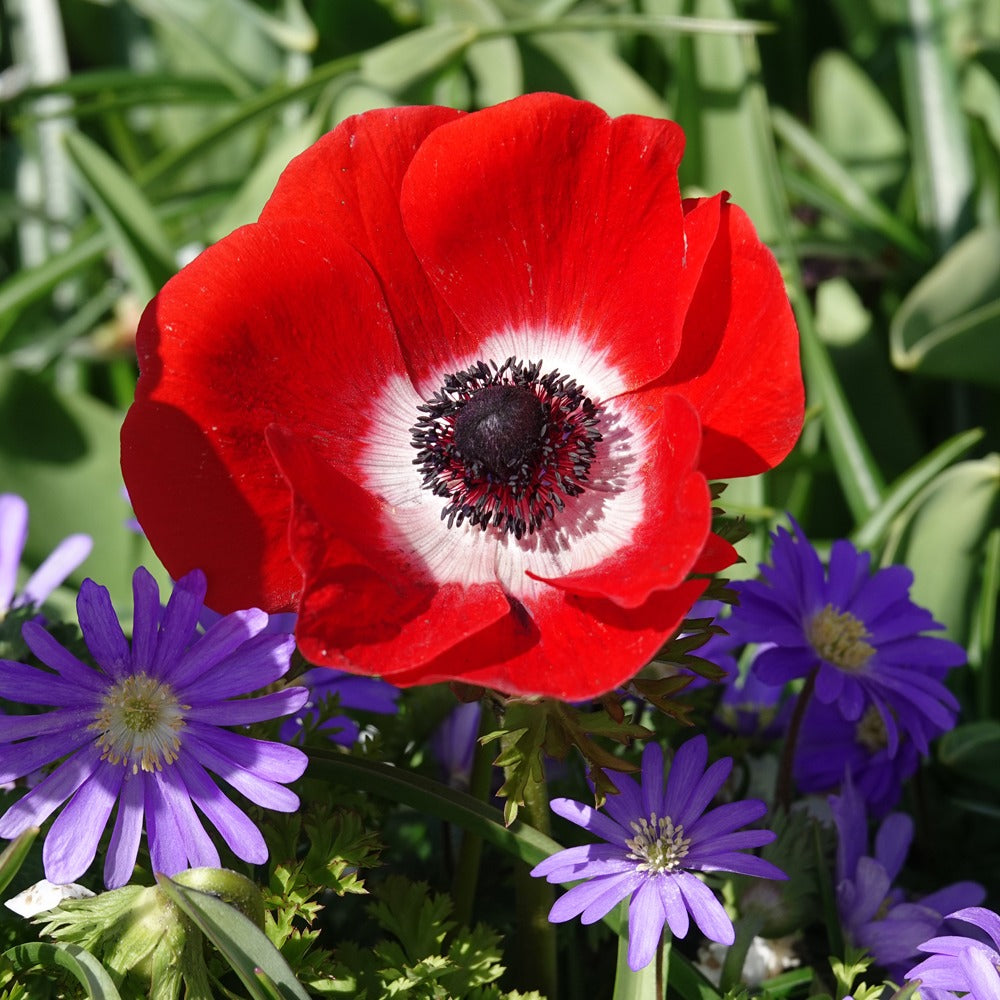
281;668;399;747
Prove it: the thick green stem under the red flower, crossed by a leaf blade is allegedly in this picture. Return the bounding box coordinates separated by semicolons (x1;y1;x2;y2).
514;752;558;998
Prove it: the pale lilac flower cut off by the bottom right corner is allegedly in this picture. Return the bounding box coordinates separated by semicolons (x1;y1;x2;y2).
906;906;1000;1000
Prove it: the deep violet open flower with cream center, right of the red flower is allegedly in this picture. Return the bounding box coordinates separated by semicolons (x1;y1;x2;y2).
730;520;965;756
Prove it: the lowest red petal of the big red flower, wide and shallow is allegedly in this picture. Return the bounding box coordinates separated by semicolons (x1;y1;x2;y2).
384;580;707;701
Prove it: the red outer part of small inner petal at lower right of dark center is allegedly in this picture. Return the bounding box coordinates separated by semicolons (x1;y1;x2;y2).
528;390;712;608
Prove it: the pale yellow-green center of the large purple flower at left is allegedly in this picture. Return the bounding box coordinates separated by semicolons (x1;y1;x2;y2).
94;673;189;774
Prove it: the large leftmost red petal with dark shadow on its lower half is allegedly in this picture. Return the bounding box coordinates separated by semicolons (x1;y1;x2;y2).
122;222;405;612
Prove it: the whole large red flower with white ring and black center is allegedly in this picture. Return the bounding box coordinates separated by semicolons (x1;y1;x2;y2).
122;94;803;699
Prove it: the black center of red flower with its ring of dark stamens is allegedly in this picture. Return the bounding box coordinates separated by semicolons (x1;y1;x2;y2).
411;357;601;538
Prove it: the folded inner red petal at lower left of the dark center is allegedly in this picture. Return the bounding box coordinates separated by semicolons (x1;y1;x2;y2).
268;427;509;677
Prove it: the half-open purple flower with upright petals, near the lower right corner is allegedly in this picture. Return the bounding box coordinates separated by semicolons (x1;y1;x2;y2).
830;779;986;978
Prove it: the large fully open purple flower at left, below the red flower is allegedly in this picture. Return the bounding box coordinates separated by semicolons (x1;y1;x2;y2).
0;568;307;888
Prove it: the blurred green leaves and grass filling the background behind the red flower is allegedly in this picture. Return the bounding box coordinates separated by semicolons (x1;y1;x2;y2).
0;0;1000;996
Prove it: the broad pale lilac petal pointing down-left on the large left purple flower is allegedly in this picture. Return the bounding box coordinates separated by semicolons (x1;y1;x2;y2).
42;764;125;885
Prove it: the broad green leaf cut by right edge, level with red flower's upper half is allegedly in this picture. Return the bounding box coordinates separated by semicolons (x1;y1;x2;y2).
889;226;1000;387
